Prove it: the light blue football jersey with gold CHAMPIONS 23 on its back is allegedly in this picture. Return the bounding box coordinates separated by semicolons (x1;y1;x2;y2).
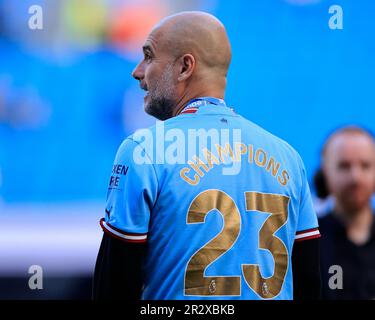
101;97;320;300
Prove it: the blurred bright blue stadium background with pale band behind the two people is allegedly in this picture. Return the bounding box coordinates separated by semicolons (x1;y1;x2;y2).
0;0;375;297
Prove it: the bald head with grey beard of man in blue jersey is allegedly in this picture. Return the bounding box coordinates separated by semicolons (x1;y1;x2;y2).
133;11;231;120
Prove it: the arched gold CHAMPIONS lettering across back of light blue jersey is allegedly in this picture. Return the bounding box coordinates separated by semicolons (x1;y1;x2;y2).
180;142;290;186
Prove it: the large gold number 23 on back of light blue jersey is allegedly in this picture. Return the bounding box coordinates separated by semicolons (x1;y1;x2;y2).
185;189;289;299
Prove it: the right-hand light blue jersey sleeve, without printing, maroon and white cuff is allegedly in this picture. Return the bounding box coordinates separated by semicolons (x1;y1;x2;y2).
295;156;320;241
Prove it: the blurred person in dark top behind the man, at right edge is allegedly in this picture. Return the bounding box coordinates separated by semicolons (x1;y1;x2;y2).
314;126;375;299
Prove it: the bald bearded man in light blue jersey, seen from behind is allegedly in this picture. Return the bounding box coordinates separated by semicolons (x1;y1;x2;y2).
94;12;320;299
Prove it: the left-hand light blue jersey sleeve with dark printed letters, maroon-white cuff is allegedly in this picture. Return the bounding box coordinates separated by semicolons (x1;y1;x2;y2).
100;138;158;242
